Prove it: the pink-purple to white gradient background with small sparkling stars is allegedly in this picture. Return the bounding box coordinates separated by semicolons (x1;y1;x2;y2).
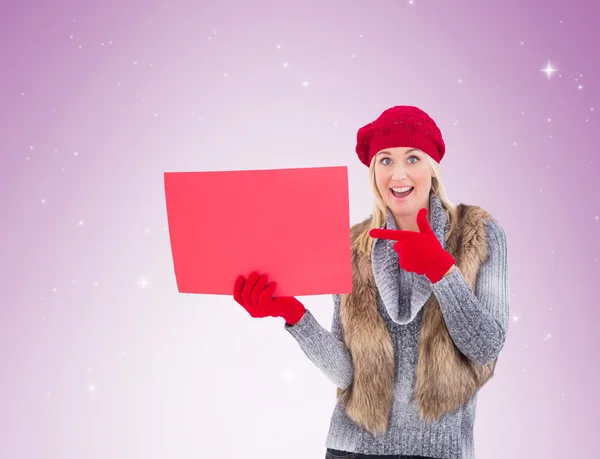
0;0;600;459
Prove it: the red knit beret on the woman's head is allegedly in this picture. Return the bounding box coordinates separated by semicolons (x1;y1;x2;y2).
356;105;446;167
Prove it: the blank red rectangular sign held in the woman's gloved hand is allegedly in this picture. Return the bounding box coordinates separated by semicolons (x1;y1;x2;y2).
164;167;352;296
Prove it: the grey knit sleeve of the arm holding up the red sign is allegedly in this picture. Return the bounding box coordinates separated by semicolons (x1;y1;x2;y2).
284;295;354;389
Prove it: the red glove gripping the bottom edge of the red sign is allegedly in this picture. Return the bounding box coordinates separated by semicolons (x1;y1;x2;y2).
233;272;306;325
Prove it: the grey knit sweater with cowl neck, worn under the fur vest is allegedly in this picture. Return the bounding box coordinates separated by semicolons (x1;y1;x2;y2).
284;196;510;459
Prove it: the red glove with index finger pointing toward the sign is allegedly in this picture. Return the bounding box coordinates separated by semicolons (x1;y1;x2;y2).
369;208;455;283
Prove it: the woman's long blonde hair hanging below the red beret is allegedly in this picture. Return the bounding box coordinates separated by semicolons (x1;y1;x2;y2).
354;154;456;257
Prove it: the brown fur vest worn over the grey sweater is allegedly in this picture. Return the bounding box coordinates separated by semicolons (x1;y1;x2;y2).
337;204;496;436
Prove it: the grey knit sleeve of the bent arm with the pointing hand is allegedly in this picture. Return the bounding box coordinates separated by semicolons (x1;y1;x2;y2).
433;219;510;365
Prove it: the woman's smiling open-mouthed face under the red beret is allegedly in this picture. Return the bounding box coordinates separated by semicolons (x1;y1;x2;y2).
373;147;432;229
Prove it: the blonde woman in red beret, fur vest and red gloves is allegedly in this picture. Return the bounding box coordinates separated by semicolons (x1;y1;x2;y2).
234;106;509;459
